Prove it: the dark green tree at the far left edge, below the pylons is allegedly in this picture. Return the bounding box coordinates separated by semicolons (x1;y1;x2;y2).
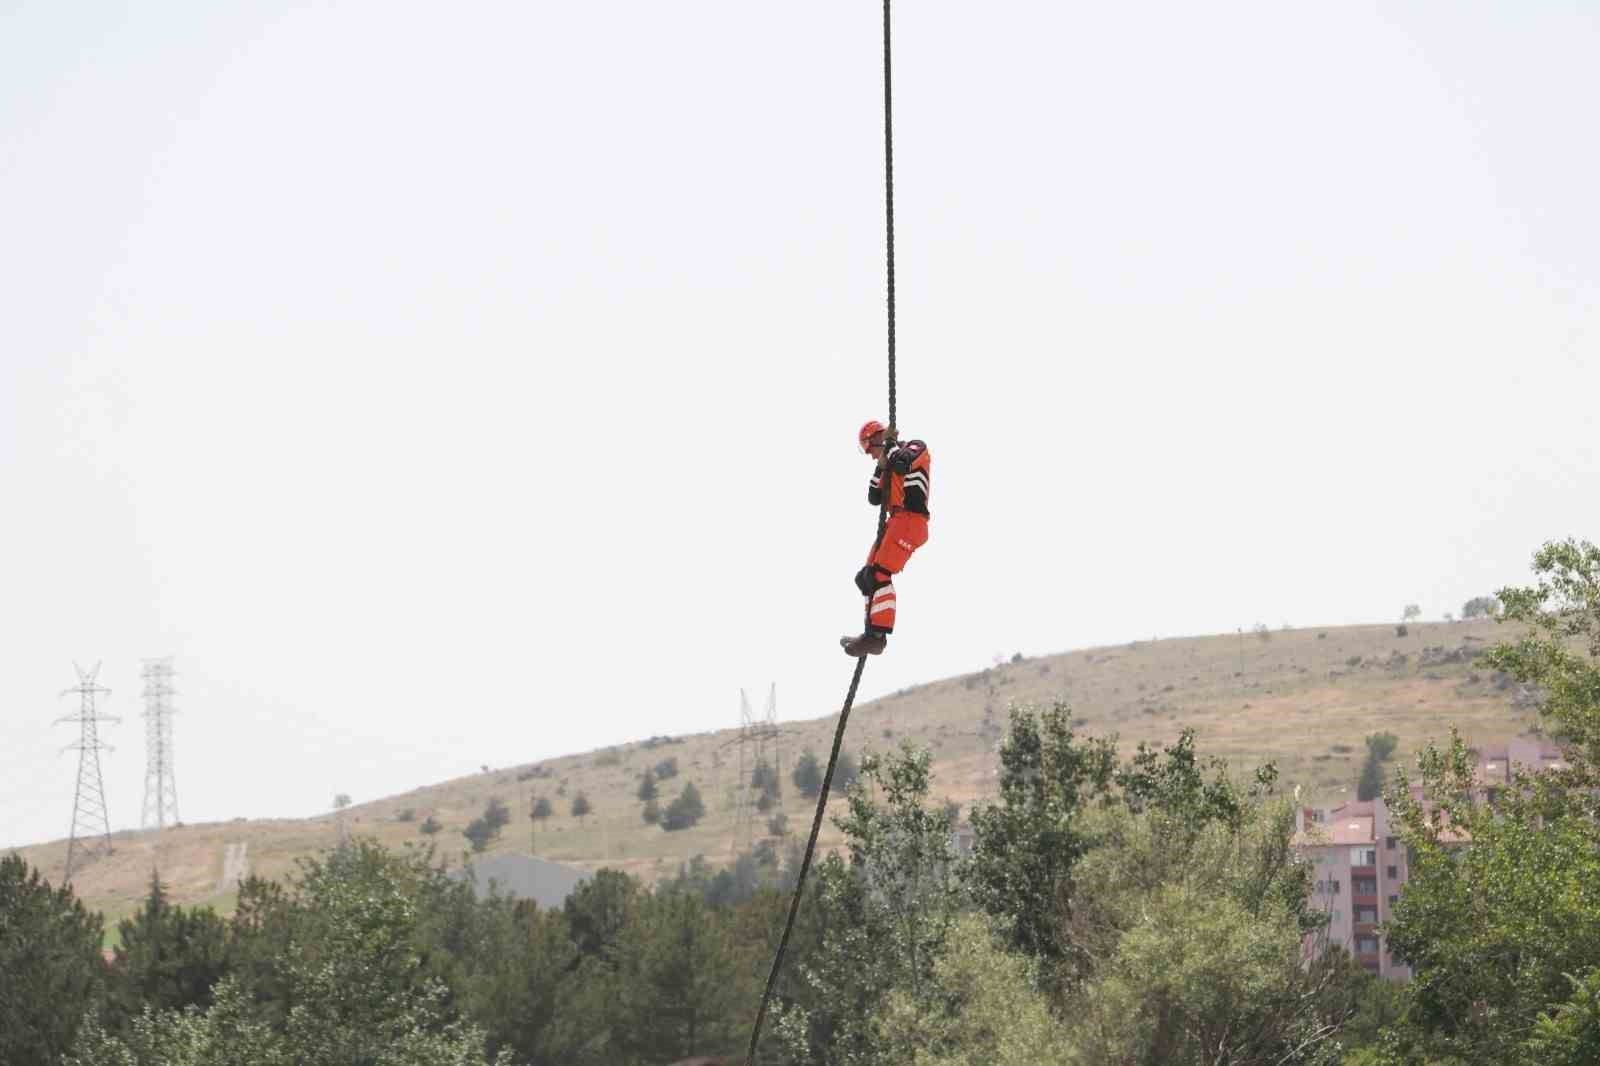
0;855;106;1063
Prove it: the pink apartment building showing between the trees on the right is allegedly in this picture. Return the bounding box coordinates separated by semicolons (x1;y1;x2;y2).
1294;739;1565;981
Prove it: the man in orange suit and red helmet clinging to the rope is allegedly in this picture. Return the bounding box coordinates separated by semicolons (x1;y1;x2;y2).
838;419;933;658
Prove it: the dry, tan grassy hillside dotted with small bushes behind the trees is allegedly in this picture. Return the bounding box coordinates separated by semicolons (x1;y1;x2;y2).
9;621;1536;920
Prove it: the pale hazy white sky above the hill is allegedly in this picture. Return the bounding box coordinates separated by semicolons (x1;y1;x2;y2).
0;0;1600;845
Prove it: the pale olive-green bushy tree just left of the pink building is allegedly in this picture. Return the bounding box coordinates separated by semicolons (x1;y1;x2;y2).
1061;784;1366;1066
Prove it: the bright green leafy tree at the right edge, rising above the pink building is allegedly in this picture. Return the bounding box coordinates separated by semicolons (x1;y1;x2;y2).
1384;539;1600;1064
